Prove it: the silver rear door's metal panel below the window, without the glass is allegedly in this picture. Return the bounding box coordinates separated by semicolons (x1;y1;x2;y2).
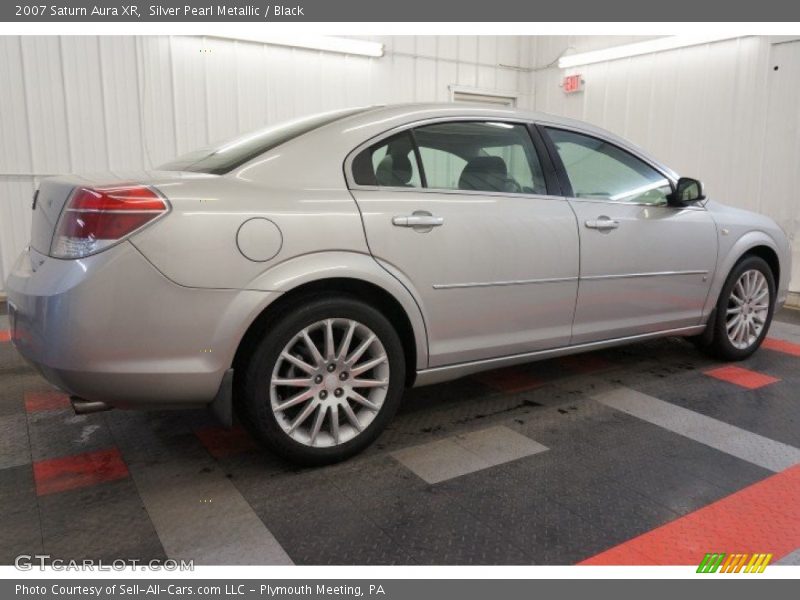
352;189;578;367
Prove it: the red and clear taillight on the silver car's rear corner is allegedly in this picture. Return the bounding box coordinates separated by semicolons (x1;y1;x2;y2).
50;185;168;258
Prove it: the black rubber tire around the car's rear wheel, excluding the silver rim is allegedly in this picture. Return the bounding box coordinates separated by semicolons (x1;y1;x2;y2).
236;295;406;466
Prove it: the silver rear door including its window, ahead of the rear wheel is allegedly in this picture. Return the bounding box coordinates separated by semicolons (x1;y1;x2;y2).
350;120;578;367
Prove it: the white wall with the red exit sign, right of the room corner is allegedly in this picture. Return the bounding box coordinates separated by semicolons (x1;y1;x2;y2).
533;36;800;292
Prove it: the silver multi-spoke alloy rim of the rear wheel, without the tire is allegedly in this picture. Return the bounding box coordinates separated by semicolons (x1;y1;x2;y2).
270;319;390;448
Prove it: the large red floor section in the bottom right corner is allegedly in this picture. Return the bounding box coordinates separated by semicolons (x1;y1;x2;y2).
579;465;800;565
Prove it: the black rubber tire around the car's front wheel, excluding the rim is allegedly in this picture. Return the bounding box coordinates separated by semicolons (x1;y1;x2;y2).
693;255;776;361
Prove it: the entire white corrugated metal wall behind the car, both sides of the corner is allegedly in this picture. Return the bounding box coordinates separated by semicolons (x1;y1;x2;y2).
0;36;800;293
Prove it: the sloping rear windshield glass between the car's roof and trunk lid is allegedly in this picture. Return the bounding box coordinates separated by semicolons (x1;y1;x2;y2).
158;108;368;175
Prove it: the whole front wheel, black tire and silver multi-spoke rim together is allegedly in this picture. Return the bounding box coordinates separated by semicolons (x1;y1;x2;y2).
708;256;775;360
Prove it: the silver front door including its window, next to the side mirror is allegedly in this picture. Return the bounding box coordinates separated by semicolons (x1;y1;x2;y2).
545;128;717;344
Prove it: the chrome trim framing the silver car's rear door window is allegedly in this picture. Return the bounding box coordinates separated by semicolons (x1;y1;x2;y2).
344;116;565;200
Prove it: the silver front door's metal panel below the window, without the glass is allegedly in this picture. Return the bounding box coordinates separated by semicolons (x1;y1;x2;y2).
570;199;717;344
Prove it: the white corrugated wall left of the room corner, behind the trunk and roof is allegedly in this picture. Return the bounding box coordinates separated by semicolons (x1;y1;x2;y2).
0;36;532;293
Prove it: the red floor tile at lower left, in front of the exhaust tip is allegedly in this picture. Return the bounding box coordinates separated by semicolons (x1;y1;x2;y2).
33;448;128;496
